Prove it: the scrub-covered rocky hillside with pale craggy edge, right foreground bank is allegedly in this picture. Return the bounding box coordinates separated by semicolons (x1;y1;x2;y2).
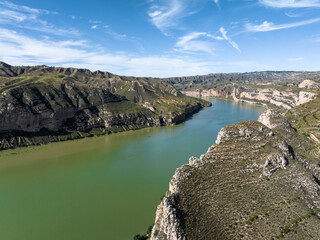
151;94;320;240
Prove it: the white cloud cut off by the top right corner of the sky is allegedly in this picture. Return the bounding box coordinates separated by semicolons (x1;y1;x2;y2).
259;0;320;8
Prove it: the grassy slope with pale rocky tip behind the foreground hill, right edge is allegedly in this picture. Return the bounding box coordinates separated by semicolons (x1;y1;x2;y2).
258;98;320;182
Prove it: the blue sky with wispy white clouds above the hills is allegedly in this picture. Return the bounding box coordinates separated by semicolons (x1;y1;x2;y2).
0;0;320;77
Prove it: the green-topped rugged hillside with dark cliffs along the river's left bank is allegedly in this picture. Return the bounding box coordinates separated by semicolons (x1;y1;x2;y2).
0;62;209;149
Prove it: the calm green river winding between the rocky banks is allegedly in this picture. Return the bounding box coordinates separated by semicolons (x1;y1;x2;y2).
0;100;264;240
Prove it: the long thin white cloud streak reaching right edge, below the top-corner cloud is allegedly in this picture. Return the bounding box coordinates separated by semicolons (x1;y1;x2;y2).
246;18;320;32
